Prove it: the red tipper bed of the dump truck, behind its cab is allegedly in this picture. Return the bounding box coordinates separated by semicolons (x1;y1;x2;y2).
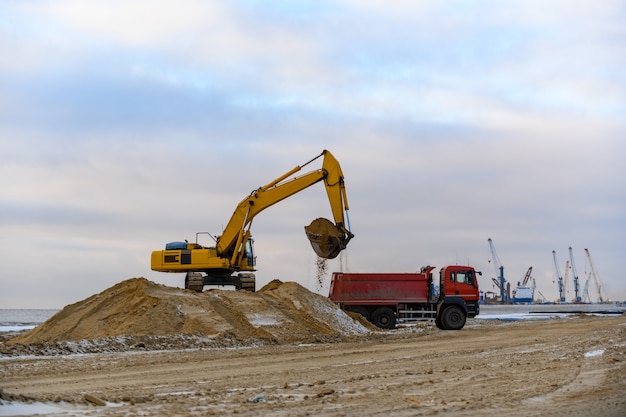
329;272;428;305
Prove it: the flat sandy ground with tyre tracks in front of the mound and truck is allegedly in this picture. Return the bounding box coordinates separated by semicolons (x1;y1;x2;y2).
0;315;626;417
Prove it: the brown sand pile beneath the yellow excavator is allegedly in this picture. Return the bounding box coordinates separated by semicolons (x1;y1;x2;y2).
6;278;370;347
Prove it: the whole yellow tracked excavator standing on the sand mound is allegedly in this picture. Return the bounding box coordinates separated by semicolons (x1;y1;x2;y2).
151;150;354;292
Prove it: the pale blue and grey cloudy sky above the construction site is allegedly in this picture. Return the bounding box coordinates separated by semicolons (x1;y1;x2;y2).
0;0;626;308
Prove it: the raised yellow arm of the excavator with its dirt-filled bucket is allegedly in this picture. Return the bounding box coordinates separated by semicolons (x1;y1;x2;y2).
216;150;354;265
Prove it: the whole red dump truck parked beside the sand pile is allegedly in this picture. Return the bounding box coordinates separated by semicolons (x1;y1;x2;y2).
329;265;481;330
